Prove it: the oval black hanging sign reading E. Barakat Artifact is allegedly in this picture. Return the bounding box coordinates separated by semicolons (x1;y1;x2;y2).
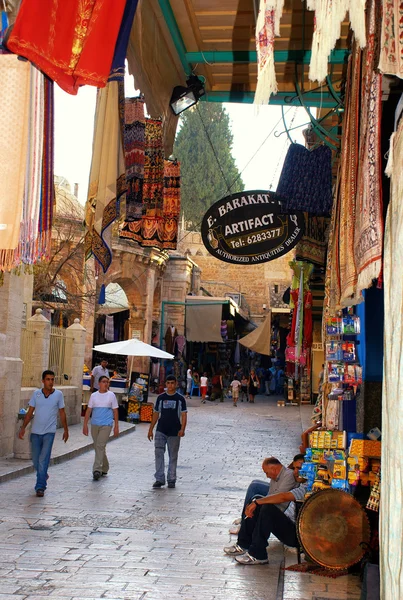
201;190;304;264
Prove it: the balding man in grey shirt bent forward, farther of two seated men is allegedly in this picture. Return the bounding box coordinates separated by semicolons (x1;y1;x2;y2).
225;455;303;554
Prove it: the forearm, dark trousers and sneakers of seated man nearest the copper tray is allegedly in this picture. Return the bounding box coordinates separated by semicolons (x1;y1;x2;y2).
224;485;306;565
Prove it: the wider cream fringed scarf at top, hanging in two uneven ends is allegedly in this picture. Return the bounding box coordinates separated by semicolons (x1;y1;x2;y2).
307;0;366;83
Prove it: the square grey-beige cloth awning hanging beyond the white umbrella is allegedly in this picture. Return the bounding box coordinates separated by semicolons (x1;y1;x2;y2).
186;299;223;343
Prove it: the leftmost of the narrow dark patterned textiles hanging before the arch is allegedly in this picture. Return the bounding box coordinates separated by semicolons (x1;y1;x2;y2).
124;98;146;222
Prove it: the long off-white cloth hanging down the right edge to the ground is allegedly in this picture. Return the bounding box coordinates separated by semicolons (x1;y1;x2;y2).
380;111;403;598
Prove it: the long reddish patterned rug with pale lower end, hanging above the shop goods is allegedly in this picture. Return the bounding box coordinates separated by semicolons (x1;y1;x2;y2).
354;0;384;294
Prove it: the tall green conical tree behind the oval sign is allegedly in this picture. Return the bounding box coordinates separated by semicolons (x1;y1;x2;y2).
174;102;245;230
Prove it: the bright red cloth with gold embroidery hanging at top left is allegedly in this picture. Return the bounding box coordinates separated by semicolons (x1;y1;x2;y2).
7;0;126;94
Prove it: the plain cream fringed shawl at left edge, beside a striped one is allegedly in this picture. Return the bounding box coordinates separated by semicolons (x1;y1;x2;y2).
0;55;31;271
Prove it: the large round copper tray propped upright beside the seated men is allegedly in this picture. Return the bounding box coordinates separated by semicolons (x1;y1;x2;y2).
297;489;370;569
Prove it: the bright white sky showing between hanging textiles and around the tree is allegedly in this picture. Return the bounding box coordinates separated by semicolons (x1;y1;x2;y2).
55;76;308;204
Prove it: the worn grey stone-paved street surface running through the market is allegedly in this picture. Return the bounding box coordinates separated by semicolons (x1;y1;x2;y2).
0;397;358;600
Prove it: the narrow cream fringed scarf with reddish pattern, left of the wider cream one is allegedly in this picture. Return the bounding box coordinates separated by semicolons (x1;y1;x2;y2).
254;0;284;104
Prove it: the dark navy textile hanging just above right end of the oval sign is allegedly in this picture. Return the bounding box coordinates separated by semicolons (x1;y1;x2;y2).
276;144;332;215
